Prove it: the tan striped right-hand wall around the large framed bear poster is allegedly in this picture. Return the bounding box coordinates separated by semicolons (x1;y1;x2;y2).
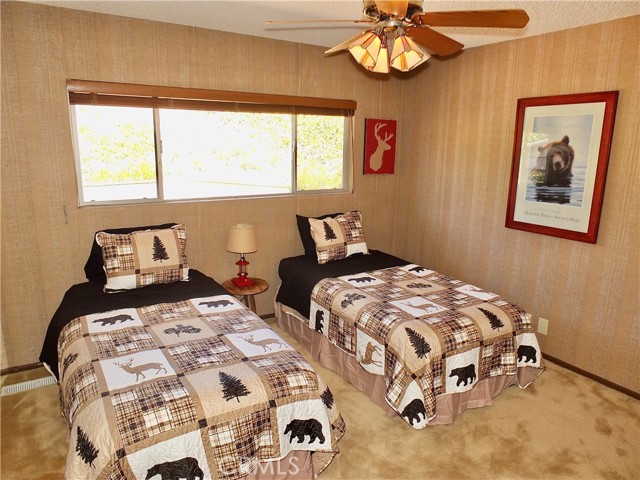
397;16;640;392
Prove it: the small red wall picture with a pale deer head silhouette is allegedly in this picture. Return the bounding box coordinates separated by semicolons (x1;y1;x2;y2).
363;118;397;175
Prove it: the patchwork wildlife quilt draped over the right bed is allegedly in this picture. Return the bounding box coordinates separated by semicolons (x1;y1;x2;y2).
309;264;544;429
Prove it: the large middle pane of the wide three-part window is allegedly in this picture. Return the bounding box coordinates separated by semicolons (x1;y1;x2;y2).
160;109;292;199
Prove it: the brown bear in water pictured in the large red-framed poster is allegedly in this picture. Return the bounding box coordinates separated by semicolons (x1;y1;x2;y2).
529;135;575;204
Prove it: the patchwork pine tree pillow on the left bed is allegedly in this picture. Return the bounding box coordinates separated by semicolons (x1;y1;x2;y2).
96;225;189;292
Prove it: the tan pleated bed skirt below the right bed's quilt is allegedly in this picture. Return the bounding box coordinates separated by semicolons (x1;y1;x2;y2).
275;302;540;425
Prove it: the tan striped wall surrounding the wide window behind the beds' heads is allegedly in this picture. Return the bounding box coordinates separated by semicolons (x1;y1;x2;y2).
1;2;402;368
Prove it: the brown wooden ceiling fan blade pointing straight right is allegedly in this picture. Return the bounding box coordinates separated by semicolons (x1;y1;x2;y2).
411;9;529;28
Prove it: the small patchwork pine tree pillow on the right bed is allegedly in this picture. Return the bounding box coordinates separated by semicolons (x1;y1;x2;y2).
309;210;369;264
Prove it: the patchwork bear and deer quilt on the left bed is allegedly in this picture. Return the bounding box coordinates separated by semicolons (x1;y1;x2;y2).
58;295;345;480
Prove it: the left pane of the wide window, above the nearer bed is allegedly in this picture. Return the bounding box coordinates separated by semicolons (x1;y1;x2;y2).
74;105;158;203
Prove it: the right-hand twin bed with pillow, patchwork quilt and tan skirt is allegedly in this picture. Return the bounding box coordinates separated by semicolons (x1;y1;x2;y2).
275;212;544;429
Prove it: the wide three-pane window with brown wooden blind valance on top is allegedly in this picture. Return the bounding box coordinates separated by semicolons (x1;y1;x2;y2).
67;80;355;205
